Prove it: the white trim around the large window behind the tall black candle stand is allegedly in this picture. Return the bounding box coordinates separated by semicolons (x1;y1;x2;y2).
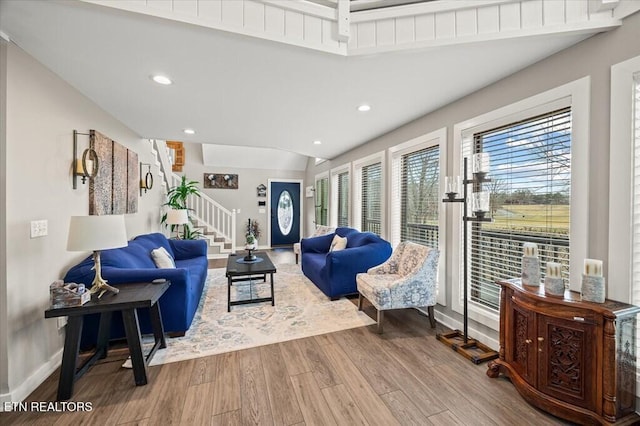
448;77;590;330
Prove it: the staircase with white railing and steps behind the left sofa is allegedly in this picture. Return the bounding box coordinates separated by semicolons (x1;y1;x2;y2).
150;139;236;258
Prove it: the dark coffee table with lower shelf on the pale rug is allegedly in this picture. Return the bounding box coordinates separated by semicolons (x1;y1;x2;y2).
226;251;276;312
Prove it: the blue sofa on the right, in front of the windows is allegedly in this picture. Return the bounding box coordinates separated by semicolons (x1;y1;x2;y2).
300;227;391;300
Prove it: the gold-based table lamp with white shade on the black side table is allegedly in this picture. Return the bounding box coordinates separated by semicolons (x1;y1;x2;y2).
67;215;128;298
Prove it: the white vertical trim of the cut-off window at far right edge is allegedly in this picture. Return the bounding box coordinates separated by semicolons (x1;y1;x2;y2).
607;56;640;303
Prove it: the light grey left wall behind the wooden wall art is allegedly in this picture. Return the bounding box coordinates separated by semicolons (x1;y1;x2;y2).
0;42;162;401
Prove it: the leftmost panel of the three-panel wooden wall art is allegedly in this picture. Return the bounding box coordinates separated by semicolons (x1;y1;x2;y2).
89;130;113;215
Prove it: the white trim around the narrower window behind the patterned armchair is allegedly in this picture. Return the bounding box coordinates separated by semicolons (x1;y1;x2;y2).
385;127;447;306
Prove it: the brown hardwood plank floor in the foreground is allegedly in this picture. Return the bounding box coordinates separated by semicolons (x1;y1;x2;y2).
0;248;566;426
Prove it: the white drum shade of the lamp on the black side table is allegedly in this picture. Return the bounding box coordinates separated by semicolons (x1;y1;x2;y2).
67;215;128;251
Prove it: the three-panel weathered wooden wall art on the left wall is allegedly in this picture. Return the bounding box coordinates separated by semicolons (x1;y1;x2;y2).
89;130;139;215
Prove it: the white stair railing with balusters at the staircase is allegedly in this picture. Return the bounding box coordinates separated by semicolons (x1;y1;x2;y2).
169;173;236;252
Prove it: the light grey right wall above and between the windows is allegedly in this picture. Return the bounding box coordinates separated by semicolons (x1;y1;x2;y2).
305;13;640;342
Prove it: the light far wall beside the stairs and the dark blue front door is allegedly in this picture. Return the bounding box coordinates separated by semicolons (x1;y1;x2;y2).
178;143;306;247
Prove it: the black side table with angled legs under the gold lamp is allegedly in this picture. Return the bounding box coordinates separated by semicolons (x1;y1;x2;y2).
44;281;171;401
